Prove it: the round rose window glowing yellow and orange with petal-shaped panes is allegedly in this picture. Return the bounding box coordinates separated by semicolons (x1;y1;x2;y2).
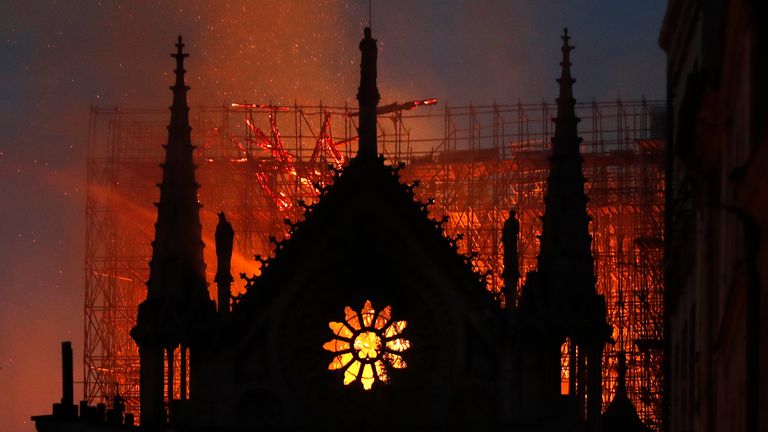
323;300;411;390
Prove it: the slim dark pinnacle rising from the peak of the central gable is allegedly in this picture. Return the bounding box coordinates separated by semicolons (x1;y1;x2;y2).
357;27;380;159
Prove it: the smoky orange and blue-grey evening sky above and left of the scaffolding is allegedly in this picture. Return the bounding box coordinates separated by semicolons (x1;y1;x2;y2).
0;0;665;431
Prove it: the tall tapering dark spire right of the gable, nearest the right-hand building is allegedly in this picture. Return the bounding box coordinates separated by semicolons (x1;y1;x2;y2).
538;29;605;339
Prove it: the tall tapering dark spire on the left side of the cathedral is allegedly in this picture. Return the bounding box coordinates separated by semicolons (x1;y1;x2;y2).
132;36;210;344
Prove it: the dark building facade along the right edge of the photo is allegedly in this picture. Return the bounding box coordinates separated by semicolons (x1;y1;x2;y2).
660;0;768;432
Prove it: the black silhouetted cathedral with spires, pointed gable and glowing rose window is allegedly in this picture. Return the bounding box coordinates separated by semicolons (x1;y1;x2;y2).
36;29;644;431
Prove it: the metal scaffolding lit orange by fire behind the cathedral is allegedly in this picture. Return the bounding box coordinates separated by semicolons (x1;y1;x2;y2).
84;100;664;430
